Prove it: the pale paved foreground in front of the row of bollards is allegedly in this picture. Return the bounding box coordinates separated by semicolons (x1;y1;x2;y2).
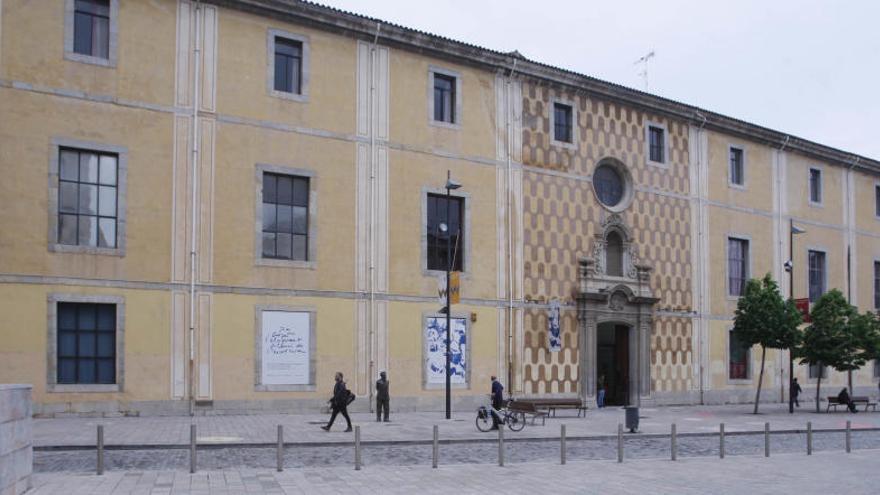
32;450;880;495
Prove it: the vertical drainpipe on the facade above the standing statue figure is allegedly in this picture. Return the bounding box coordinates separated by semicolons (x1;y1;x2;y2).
365;22;382;412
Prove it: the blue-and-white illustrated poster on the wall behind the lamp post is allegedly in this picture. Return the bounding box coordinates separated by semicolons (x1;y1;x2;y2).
424;316;468;385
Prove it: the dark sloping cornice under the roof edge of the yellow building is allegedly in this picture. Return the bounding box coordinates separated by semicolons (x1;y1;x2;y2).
204;0;880;175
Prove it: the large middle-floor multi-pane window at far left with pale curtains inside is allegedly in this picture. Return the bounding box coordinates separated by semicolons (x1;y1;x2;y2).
58;148;119;248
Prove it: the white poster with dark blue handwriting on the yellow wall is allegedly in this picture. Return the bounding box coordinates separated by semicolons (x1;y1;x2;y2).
260;311;311;385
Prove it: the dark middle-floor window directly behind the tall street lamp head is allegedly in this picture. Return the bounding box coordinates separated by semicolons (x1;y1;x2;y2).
427;194;464;272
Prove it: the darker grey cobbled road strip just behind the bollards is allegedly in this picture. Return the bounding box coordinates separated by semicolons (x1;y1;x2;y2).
34;431;880;473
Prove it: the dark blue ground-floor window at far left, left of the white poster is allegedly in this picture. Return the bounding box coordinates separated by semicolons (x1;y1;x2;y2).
57;302;116;384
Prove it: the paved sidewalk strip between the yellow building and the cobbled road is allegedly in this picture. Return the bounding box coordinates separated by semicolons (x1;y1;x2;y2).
34;403;880;446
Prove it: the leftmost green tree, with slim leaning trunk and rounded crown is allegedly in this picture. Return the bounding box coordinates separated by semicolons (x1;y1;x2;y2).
733;273;801;414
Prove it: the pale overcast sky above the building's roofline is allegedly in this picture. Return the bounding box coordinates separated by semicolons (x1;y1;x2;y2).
319;0;880;159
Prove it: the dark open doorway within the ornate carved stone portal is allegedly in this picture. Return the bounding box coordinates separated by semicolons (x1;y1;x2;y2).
596;323;629;406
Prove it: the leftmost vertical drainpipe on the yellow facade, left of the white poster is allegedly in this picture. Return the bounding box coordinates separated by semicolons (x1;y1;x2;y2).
189;2;202;416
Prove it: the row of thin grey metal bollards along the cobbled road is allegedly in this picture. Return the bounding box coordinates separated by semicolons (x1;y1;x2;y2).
97;421;852;475
